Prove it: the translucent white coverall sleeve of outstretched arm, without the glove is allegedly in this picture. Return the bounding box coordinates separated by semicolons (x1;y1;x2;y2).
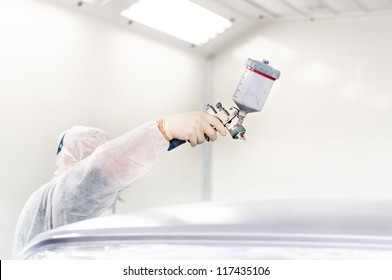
53;122;169;227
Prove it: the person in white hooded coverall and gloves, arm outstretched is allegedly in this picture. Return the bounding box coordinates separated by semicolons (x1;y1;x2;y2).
13;112;226;255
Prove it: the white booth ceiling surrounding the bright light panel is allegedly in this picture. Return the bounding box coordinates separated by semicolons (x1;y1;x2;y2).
46;0;392;54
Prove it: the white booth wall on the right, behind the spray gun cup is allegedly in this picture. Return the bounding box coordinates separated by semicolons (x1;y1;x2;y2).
212;17;392;200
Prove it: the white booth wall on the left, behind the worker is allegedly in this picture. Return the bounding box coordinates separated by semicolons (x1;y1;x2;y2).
0;0;204;259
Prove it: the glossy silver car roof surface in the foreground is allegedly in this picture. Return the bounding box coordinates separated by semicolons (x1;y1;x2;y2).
18;200;392;259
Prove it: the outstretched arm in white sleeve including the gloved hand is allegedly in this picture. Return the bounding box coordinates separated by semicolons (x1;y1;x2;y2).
53;112;226;227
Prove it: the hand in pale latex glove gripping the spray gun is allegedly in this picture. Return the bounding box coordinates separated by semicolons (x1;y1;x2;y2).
159;112;226;147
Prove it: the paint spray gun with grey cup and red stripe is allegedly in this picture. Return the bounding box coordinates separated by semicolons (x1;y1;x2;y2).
168;58;280;151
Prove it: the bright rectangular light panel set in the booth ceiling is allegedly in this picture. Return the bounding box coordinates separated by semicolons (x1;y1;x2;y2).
121;0;232;45
